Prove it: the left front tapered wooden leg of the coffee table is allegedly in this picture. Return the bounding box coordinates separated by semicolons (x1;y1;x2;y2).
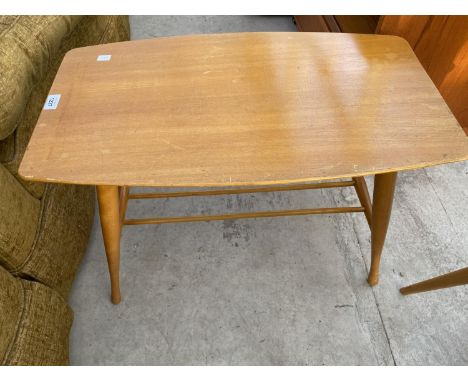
96;186;120;304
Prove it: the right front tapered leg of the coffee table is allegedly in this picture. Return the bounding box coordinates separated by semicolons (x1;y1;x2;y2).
367;172;397;286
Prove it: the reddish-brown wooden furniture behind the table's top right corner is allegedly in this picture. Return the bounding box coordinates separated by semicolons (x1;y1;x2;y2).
294;16;468;135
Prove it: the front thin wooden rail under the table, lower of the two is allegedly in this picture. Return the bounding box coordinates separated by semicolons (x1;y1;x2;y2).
123;207;365;225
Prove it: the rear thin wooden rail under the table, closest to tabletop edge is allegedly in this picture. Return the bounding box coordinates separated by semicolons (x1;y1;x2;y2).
128;180;355;199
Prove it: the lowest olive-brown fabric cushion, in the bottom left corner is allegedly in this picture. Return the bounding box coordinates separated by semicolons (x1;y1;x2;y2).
0;267;73;365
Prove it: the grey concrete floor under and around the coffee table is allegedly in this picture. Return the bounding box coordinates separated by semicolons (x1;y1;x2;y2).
70;16;468;365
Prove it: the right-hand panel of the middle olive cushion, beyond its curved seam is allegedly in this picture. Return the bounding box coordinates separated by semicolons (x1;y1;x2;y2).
10;184;95;297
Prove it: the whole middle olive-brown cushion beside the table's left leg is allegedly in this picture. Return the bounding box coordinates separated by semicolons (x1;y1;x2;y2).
0;161;95;296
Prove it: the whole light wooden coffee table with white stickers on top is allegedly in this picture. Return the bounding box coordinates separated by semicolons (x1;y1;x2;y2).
19;33;468;304
